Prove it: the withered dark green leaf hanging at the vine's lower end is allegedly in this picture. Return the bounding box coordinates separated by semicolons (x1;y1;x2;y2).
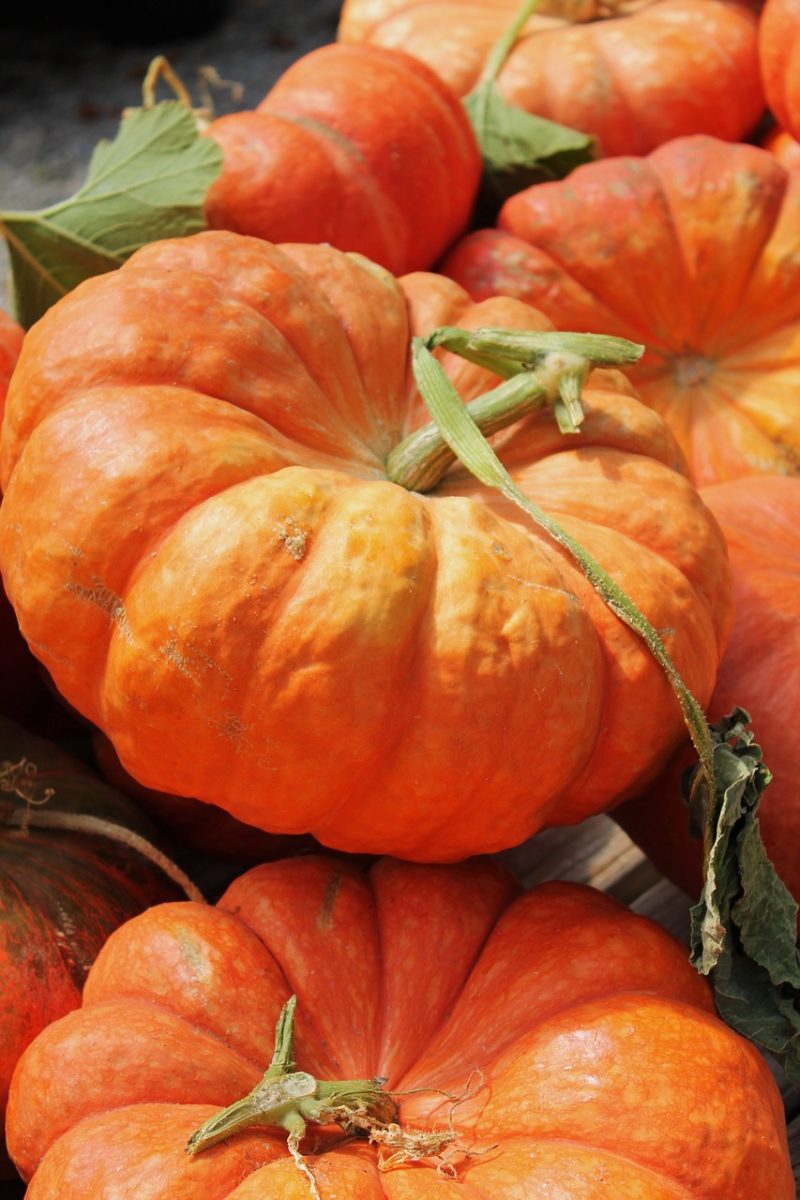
688;709;800;1081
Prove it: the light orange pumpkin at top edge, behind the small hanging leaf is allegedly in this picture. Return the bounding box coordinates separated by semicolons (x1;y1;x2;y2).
338;0;764;155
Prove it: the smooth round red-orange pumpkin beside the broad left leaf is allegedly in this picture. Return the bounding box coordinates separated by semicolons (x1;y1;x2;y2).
205;46;481;274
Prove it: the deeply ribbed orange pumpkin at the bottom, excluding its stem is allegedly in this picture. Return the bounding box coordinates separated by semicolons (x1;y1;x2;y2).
8;857;794;1200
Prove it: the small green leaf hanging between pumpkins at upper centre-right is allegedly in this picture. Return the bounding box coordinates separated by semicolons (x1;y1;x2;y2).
464;79;596;210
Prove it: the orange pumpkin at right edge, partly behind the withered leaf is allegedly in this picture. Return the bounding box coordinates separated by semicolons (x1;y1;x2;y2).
614;476;800;899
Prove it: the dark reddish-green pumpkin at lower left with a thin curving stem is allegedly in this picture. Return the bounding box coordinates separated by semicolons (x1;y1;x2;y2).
0;718;194;1169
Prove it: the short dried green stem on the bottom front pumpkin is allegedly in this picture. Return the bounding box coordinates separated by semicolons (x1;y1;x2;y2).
186;996;397;1156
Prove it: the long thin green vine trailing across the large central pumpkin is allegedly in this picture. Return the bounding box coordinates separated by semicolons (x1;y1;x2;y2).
411;331;715;804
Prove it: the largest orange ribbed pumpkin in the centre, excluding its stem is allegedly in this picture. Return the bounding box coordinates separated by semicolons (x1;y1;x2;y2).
0;233;729;860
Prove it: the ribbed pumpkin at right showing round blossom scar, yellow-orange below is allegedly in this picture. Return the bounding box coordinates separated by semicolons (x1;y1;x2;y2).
443;136;800;485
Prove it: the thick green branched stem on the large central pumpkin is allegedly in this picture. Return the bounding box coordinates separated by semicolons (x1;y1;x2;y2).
386;325;644;492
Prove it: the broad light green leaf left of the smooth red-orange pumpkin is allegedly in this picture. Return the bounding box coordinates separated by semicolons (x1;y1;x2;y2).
0;100;222;328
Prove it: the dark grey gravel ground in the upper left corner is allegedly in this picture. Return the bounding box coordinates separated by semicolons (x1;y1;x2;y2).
0;0;341;310
